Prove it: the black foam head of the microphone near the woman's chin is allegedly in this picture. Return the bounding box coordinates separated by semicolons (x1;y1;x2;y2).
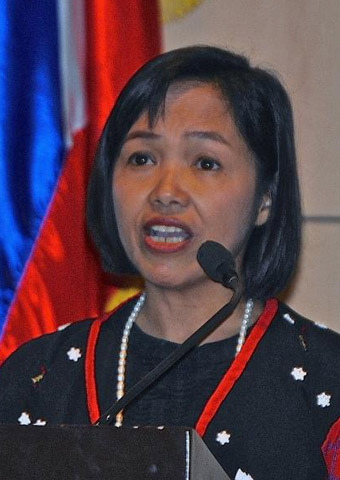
197;240;238;289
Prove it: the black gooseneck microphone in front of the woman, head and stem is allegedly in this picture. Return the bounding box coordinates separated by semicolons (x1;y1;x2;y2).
93;240;242;426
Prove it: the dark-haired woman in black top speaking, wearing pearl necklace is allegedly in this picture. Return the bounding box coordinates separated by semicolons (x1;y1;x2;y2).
0;47;340;480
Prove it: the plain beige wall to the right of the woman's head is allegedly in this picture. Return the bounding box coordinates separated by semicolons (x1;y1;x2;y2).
163;0;340;331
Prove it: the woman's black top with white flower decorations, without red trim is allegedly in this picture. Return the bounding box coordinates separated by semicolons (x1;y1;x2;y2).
0;301;340;480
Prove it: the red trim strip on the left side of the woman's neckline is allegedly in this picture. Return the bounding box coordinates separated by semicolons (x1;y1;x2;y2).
85;293;140;424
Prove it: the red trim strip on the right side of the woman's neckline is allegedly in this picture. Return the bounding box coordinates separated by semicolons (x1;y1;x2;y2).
195;299;278;437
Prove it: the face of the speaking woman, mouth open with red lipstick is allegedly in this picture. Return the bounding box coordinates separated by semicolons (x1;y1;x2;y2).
113;84;267;288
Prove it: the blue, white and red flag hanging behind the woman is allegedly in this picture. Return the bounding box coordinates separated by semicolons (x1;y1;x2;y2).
0;0;160;360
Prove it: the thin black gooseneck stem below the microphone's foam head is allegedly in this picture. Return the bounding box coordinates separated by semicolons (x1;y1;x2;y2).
94;284;242;426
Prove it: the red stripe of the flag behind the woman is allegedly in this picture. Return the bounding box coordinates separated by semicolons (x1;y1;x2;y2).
0;0;160;361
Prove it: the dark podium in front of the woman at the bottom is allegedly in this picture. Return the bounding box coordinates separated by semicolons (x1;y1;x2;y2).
0;425;230;480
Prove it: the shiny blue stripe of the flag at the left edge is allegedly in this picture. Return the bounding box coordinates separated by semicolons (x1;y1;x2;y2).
0;0;64;330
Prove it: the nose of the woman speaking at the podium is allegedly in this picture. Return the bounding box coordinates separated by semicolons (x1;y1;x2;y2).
149;168;190;213
